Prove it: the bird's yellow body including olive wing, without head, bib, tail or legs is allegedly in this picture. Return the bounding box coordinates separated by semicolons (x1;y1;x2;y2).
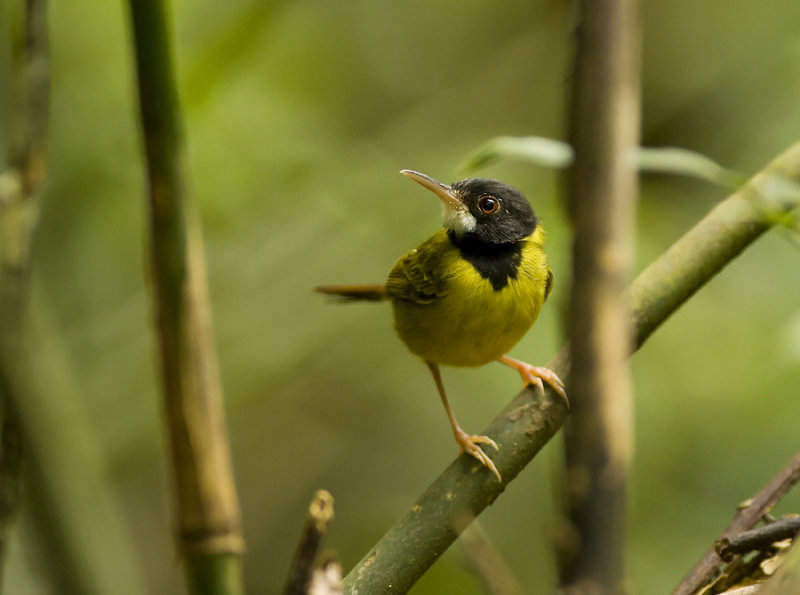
387;227;551;366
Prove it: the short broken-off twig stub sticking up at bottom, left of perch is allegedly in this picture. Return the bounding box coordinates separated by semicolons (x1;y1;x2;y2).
284;490;333;595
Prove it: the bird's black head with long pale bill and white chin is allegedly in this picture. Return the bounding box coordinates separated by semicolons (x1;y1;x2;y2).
400;169;538;244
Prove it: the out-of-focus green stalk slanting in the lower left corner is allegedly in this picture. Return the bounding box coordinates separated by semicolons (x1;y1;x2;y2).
4;336;147;595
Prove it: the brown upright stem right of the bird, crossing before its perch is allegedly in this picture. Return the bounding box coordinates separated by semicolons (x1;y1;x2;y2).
559;0;640;593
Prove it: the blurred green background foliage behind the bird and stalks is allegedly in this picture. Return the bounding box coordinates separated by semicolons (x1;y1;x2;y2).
0;0;800;595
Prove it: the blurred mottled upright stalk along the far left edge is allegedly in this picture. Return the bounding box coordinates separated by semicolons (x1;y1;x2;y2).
0;0;50;584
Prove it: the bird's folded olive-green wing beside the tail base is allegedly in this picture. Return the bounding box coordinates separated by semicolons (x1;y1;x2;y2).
386;234;447;304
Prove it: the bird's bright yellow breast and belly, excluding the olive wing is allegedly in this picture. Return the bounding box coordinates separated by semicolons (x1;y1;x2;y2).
392;233;549;366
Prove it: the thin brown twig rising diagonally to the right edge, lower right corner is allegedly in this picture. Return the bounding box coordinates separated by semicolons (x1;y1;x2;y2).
674;453;800;595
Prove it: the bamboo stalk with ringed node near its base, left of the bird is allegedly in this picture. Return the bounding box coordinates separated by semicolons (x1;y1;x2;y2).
129;0;244;593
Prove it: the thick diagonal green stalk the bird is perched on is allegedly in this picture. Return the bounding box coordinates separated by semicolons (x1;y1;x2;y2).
345;143;800;595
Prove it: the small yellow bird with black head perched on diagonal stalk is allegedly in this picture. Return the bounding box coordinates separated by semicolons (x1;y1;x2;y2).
314;169;568;483
